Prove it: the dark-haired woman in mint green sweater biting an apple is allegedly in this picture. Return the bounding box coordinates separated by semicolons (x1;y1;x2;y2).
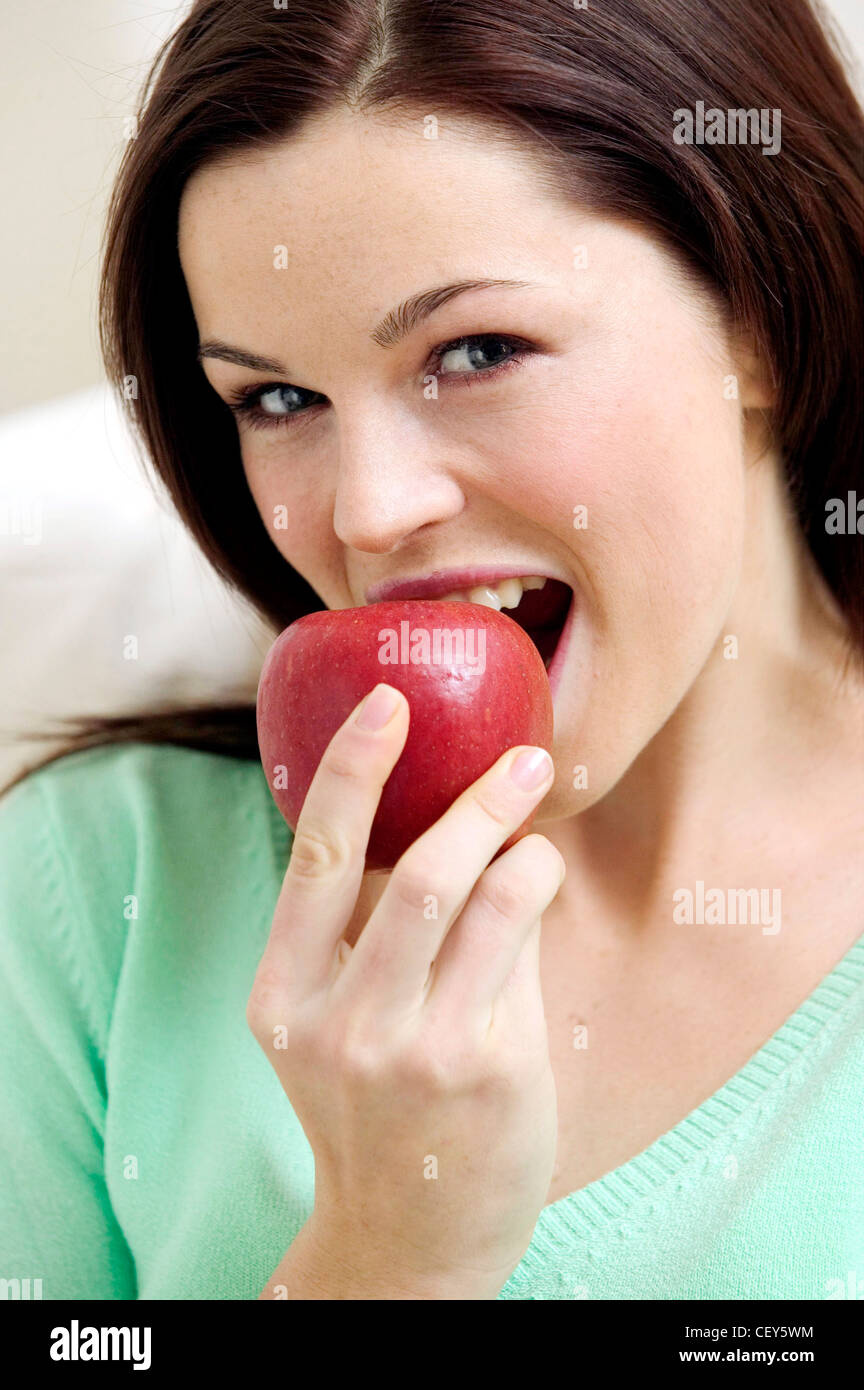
0;0;864;1300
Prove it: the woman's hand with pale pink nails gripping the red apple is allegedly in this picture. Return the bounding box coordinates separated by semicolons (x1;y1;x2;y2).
247;685;564;1298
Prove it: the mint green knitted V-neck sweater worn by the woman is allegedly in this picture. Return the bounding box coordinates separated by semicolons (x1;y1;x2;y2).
0;744;864;1300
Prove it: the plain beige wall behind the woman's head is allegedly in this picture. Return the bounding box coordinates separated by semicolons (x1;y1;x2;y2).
0;0;864;411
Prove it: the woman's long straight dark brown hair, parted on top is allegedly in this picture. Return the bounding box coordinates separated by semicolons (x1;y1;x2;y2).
3;0;864;795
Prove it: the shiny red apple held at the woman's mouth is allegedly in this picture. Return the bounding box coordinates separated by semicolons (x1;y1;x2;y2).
257;599;553;873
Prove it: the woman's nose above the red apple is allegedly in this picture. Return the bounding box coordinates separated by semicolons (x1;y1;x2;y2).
333;403;465;555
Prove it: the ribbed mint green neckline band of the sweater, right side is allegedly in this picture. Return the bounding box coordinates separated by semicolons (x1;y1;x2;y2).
540;935;864;1234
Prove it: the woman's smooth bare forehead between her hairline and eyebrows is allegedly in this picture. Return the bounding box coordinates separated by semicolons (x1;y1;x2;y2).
178;111;697;361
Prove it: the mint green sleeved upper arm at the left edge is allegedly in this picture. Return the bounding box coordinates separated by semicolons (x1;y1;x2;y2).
0;777;136;1300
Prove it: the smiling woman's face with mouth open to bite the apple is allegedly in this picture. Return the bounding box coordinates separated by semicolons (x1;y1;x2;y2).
179;114;747;821
